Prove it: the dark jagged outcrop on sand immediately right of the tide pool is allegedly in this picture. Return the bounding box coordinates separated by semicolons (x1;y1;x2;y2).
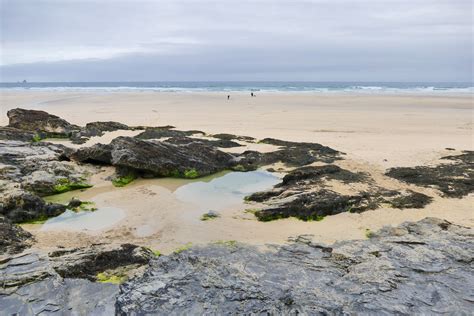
246;165;432;221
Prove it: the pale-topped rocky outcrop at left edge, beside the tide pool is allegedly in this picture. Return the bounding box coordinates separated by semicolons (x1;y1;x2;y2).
0;141;91;223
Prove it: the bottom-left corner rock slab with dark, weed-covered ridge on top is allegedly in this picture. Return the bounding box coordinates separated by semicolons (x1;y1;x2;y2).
0;245;153;315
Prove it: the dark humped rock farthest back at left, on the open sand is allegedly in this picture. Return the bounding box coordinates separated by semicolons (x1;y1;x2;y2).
7;108;79;137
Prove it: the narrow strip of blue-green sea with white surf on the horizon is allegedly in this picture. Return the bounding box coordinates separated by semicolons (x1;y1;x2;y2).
0;81;474;95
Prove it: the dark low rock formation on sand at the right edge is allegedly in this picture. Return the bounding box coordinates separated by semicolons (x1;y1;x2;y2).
386;151;474;198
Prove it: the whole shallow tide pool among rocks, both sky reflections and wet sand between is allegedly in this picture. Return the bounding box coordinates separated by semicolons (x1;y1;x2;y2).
41;170;281;232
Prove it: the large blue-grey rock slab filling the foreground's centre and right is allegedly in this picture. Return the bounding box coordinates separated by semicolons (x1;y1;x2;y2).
116;218;474;315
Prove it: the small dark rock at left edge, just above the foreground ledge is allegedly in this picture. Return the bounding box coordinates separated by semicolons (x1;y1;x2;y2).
0;216;33;255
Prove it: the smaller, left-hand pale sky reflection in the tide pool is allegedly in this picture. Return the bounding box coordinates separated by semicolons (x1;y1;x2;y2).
41;207;125;231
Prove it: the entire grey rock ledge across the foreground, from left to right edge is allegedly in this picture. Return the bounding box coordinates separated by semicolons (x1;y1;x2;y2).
0;218;474;315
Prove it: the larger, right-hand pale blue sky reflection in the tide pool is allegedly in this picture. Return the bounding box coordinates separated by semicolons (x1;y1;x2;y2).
174;170;280;210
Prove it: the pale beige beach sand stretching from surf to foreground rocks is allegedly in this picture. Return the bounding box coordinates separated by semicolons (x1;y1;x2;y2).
0;91;474;252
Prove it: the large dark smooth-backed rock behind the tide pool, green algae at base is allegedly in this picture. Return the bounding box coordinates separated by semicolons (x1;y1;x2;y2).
72;137;233;178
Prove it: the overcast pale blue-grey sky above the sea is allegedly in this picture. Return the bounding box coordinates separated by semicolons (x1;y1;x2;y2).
0;0;473;82
